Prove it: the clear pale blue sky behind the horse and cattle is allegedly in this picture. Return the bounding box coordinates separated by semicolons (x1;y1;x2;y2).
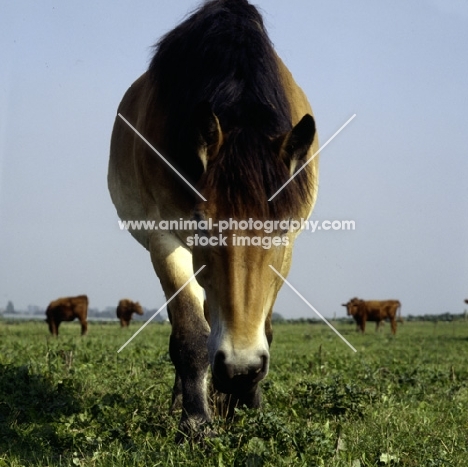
0;0;468;317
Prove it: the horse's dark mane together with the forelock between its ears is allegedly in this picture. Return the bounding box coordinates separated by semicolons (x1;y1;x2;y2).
149;0;307;217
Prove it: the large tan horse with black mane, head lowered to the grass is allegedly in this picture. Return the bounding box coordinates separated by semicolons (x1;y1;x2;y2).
108;0;318;440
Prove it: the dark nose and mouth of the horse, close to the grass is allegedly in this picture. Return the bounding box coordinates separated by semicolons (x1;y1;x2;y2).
212;350;269;394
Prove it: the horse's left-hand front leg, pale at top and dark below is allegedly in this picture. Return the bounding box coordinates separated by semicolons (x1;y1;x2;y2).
150;237;211;441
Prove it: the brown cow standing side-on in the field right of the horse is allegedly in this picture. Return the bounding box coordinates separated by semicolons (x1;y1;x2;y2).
342;298;401;334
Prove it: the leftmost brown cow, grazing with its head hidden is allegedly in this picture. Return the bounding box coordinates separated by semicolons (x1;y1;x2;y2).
46;295;88;336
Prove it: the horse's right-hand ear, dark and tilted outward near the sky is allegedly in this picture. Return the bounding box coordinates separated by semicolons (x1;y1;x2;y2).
280;114;315;175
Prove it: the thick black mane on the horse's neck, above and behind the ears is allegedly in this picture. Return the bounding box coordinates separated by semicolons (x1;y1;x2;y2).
149;0;290;152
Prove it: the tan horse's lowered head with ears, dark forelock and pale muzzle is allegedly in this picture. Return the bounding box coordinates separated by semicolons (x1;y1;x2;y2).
193;105;315;394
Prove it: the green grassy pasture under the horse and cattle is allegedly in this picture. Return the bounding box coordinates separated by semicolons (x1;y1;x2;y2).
0;320;468;467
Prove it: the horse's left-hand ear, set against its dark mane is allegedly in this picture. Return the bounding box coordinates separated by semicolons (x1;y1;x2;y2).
193;102;223;170
